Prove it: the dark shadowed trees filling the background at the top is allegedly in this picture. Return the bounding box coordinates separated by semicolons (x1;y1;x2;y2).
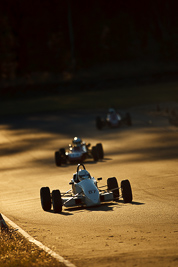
0;0;178;79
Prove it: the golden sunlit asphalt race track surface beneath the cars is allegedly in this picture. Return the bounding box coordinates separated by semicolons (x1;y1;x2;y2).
0;107;178;267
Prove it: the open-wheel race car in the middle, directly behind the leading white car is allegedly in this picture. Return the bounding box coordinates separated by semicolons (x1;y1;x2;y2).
54;137;104;166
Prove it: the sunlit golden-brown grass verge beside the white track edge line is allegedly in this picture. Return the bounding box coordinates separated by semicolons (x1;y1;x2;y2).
0;227;65;267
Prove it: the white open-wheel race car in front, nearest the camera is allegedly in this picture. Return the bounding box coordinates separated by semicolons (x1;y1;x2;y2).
40;164;132;213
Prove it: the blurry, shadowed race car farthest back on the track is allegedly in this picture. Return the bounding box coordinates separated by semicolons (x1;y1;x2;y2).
96;108;132;130
